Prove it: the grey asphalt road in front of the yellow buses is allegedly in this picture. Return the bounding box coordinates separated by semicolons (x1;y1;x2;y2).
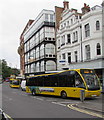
2;83;101;119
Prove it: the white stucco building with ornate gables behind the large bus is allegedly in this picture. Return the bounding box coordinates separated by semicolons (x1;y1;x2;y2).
56;2;104;80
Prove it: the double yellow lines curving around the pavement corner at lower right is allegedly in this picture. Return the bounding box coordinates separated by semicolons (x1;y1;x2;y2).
67;104;104;118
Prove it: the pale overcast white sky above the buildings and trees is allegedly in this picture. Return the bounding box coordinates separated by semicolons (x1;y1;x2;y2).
0;0;102;69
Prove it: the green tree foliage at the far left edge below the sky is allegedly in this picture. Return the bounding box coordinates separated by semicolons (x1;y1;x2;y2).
0;59;19;79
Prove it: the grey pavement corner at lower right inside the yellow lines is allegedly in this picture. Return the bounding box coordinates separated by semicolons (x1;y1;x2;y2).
74;94;104;115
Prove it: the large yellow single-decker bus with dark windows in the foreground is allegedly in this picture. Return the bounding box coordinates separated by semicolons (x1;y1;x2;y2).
26;69;101;98
